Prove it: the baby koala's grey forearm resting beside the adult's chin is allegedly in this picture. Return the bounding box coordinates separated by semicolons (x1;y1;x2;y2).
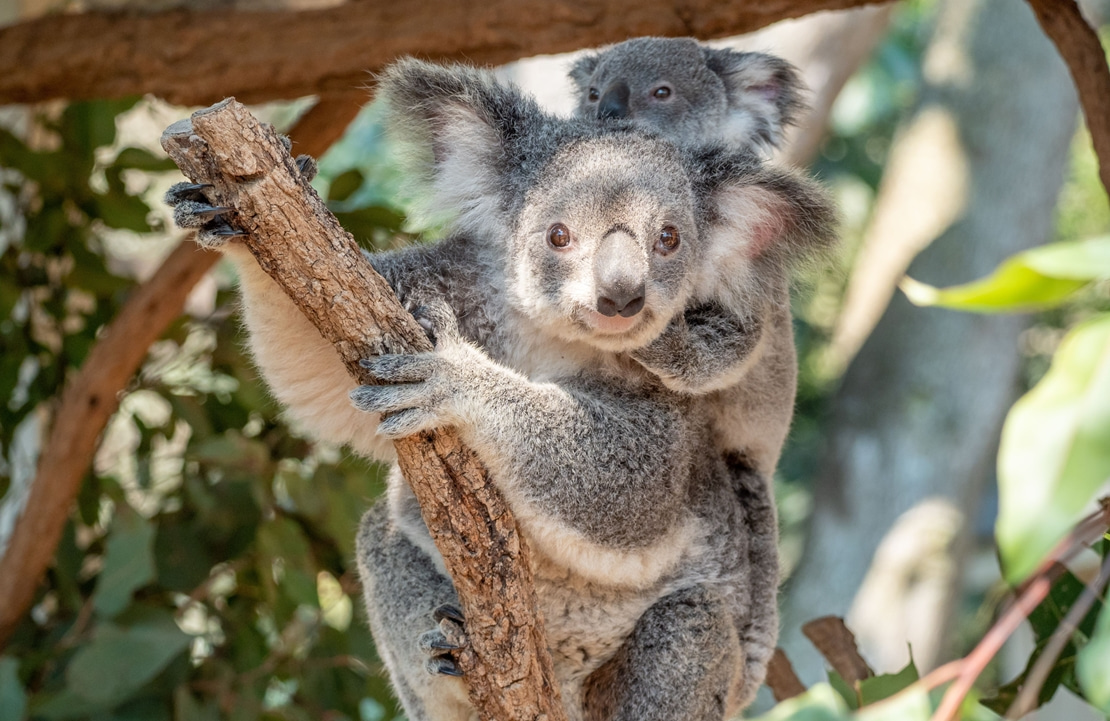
630;302;764;395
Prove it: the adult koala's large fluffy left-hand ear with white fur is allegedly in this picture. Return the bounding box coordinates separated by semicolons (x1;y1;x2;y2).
379;58;545;233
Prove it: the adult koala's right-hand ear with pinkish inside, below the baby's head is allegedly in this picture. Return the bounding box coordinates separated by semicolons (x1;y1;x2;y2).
705;155;837;267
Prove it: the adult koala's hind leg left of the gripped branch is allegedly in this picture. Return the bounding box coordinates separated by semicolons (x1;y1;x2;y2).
357;501;477;721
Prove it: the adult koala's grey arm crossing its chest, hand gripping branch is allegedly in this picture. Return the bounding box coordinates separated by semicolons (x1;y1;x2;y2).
352;304;692;563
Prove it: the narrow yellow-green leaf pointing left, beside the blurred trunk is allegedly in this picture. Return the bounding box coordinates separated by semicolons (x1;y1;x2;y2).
901;237;1110;313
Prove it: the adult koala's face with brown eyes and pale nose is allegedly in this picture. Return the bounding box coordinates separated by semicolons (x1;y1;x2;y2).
507;134;698;352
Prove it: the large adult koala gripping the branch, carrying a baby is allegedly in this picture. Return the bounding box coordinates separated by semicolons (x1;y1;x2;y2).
168;60;826;721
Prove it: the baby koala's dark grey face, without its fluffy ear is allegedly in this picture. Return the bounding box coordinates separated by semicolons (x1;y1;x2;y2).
572;38;728;148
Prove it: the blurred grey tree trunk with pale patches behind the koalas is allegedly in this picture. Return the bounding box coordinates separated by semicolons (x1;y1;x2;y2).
784;0;1077;680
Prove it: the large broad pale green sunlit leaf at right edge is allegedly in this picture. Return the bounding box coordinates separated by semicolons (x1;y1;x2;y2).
995;314;1110;585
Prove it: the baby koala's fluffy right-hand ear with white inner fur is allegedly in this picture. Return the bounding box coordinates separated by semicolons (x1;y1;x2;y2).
702;48;807;148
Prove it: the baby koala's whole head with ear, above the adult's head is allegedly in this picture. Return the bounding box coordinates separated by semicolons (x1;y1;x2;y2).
569;38;805;148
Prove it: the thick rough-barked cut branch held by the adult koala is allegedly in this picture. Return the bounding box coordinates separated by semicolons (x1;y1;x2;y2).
162;100;565;721
